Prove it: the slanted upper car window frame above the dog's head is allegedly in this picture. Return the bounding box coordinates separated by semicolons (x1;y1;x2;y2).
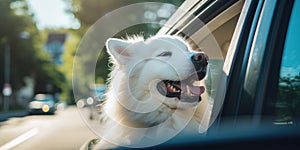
157;0;239;37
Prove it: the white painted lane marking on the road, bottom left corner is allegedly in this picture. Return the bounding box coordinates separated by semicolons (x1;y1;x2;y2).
0;128;39;150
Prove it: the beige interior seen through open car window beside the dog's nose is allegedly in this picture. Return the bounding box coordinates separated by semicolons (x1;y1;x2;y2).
181;1;244;128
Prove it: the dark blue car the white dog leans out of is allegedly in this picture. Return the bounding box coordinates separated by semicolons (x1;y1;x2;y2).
154;0;300;149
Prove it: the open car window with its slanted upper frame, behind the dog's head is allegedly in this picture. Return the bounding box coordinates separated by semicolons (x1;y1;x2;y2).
158;0;245;131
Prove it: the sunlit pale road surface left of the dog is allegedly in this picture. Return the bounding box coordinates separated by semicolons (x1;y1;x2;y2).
0;106;97;150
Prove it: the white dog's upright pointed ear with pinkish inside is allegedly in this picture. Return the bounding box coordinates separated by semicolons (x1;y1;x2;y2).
106;38;130;64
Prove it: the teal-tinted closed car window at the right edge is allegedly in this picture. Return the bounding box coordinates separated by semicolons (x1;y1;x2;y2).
274;0;300;125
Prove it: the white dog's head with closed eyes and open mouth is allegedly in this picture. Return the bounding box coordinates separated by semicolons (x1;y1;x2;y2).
106;36;208;109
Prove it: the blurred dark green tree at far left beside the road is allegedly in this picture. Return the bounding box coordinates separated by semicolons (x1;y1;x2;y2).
0;0;64;102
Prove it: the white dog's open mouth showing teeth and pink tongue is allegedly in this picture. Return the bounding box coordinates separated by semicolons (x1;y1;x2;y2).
157;80;205;103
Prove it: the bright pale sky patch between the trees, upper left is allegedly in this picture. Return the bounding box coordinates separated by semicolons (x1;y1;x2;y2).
26;0;80;29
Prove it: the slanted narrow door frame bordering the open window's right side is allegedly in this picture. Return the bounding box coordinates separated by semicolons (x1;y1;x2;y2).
210;0;258;128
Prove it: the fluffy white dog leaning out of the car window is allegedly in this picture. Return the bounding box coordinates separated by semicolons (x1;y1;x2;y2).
95;36;208;149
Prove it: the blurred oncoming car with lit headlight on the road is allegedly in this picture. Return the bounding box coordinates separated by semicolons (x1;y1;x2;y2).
28;94;56;114
